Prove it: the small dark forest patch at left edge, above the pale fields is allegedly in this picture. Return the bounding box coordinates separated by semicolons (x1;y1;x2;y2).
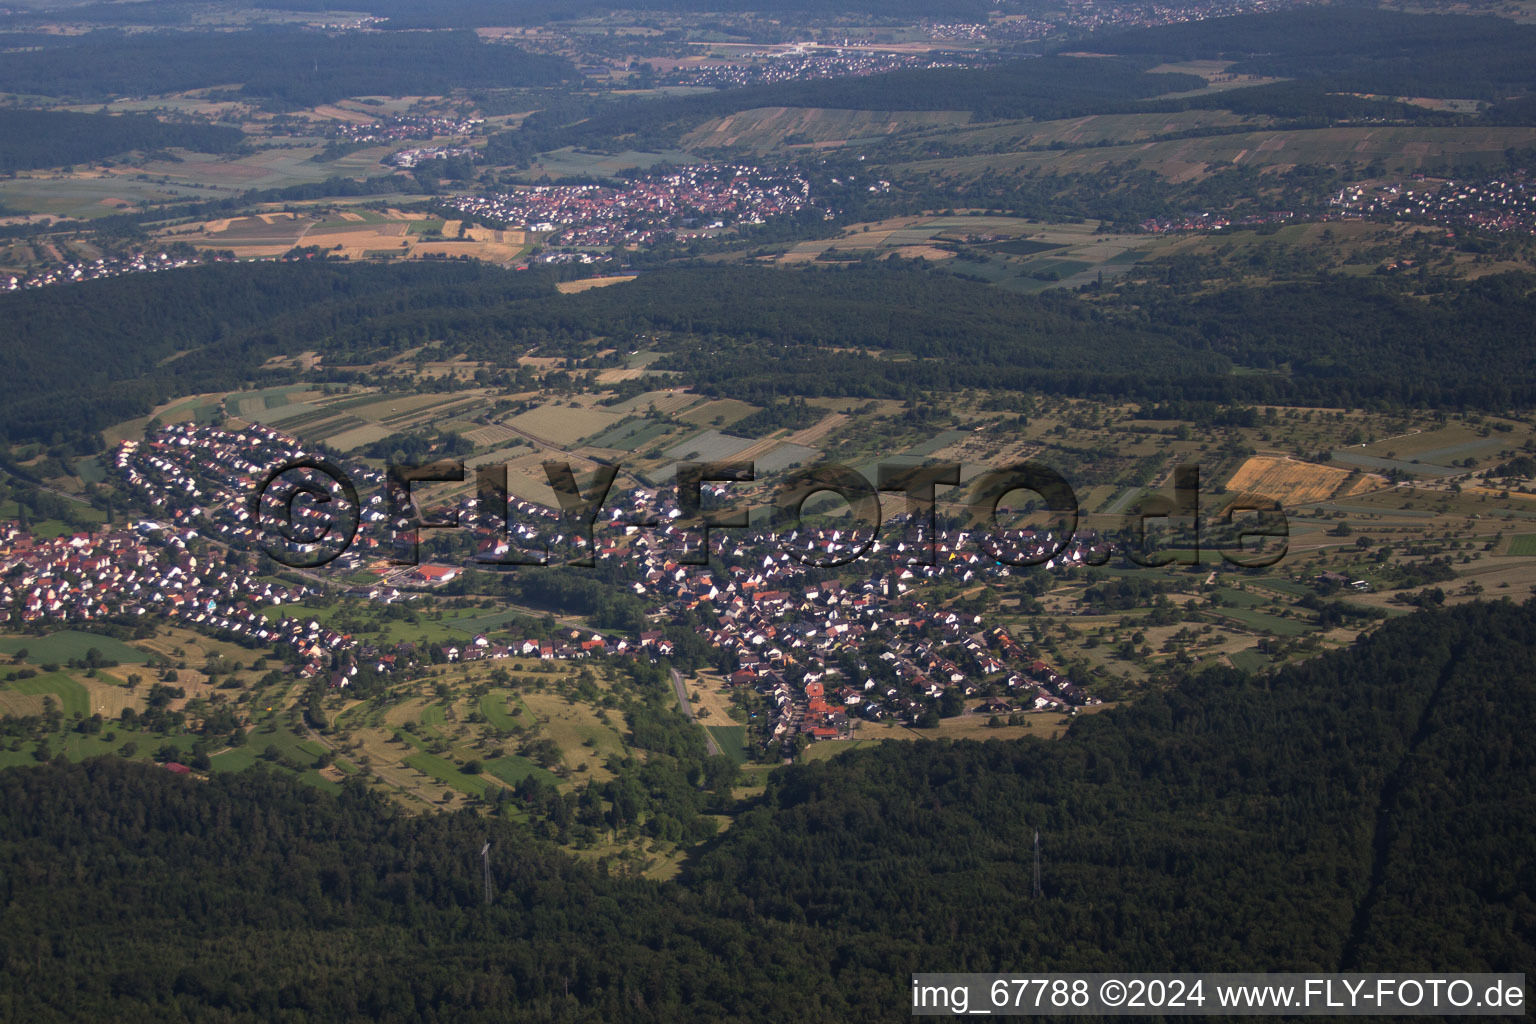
0;111;246;172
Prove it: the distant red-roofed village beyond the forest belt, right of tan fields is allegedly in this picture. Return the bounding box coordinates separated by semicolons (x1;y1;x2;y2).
447;164;833;246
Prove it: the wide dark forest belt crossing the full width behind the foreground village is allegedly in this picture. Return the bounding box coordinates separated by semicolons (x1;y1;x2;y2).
0;263;1536;450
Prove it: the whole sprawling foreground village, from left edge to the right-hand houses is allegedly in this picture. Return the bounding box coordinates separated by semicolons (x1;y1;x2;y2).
0;424;1098;761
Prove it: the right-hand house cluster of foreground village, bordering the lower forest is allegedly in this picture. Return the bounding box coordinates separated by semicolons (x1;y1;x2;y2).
577;512;1098;738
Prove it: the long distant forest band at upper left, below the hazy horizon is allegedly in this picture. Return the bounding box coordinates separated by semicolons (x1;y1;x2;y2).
0;29;574;107
